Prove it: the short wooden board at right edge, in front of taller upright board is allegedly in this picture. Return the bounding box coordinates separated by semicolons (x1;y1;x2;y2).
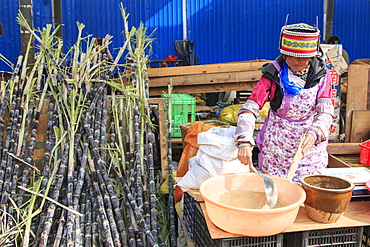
350;110;370;142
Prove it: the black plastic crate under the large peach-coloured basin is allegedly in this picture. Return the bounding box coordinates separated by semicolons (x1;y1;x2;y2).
194;203;283;247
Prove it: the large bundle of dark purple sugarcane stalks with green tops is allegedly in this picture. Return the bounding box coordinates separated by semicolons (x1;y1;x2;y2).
0;5;176;246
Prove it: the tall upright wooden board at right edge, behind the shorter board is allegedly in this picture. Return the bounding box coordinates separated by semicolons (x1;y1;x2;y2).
345;59;370;142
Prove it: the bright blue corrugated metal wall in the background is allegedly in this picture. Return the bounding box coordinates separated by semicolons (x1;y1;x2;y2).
0;0;370;70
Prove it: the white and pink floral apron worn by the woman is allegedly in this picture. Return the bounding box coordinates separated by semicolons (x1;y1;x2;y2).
257;85;328;183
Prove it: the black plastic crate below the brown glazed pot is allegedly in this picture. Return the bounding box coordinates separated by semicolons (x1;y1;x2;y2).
284;227;363;247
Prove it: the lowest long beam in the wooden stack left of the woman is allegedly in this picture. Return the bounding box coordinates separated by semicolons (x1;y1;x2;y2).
149;81;257;96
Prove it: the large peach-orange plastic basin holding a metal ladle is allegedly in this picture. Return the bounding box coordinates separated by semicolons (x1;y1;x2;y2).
199;173;306;237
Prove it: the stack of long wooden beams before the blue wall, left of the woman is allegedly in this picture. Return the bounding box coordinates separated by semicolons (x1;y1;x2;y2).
115;60;264;96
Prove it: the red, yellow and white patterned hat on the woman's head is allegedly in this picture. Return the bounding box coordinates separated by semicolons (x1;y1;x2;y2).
280;23;320;57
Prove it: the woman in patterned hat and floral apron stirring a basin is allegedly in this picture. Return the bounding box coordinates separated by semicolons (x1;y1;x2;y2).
235;23;334;182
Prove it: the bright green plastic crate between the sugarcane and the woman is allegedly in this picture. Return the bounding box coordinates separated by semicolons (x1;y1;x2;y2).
162;94;196;137
